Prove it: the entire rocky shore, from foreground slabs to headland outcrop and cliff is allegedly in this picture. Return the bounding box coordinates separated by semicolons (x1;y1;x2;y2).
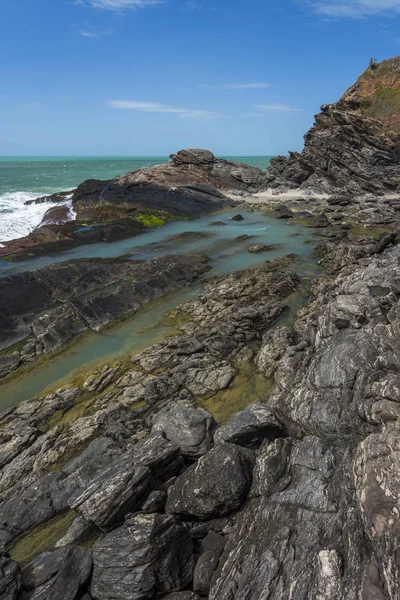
0;58;400;600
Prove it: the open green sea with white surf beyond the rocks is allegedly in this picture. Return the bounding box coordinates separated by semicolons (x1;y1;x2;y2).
0;156;271;243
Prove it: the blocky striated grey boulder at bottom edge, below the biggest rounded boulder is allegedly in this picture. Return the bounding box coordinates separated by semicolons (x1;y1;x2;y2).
90;514;194;600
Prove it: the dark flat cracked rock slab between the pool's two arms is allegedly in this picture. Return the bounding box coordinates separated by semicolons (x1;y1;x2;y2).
0;255;208;376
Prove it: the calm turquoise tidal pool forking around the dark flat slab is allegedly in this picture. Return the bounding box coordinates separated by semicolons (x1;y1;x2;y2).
0;209;319;409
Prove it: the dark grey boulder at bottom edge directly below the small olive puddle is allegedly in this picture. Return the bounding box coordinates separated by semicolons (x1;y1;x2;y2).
22;546;92;600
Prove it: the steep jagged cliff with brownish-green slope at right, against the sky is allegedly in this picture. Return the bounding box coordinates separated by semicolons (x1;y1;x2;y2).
267;57;400;195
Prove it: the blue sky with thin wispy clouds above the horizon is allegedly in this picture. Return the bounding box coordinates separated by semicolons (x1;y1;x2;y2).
0;0;400;155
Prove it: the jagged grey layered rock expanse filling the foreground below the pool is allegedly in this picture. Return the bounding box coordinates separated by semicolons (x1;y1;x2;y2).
0;179;400;600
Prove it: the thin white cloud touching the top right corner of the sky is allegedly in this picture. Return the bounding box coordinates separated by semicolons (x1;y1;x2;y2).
300;0;400;19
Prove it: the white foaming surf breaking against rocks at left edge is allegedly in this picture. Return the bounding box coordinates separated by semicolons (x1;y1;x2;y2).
0;192;60;242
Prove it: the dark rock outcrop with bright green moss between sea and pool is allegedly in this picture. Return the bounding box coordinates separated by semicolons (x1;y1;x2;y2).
0;149;265;260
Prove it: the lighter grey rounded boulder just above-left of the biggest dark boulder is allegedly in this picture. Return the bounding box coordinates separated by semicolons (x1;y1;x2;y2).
153;405;217;458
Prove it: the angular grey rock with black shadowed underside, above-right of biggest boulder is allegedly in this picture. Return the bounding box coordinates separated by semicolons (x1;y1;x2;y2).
214;402;284;448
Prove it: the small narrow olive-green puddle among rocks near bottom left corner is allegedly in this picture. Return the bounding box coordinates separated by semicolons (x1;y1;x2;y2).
8;510;78;564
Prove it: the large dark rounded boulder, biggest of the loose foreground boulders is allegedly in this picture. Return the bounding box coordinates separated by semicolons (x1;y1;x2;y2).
166;444;254;520
